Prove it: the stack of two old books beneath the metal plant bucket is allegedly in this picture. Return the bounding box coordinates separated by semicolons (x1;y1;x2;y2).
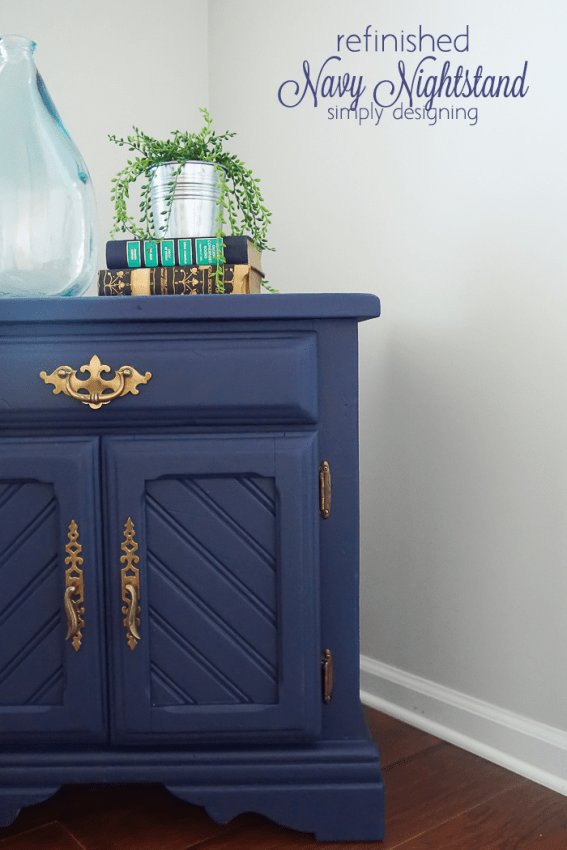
98;236;264;295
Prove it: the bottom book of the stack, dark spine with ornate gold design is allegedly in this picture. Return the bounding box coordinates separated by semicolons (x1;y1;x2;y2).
98;264;262;295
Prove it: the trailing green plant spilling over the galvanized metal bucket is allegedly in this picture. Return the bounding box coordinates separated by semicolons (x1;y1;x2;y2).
109;109;275;292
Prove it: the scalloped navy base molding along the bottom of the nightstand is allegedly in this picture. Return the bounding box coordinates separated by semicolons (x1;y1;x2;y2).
0;741;384;841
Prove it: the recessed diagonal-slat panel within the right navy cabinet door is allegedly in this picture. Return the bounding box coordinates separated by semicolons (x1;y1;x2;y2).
146;476;278;705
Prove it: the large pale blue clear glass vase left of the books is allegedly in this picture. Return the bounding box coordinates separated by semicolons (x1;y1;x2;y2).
0;35;97;297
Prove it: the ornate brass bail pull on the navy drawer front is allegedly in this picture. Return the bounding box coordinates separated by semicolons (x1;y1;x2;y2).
39;354;152;410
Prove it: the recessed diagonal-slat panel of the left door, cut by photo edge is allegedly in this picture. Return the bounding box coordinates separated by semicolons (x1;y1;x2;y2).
0;481;64;706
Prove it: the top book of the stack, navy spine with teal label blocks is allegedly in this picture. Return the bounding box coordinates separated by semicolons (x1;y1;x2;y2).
106;236;261;271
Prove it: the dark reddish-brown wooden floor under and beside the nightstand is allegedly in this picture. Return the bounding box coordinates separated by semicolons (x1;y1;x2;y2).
0;709;567;850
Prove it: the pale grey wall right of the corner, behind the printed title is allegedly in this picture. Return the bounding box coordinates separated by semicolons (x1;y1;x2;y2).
209;0;567;730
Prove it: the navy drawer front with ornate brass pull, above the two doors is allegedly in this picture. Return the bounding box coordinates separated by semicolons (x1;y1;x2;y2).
0;331;317;428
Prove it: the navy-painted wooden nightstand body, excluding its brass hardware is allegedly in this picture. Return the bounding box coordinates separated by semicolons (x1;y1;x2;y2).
0;295;384;841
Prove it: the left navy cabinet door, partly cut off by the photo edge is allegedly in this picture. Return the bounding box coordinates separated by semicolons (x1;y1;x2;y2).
0;438;106;743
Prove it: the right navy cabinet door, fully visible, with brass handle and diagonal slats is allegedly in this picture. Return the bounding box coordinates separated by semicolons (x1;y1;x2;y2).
105;434;321;743
